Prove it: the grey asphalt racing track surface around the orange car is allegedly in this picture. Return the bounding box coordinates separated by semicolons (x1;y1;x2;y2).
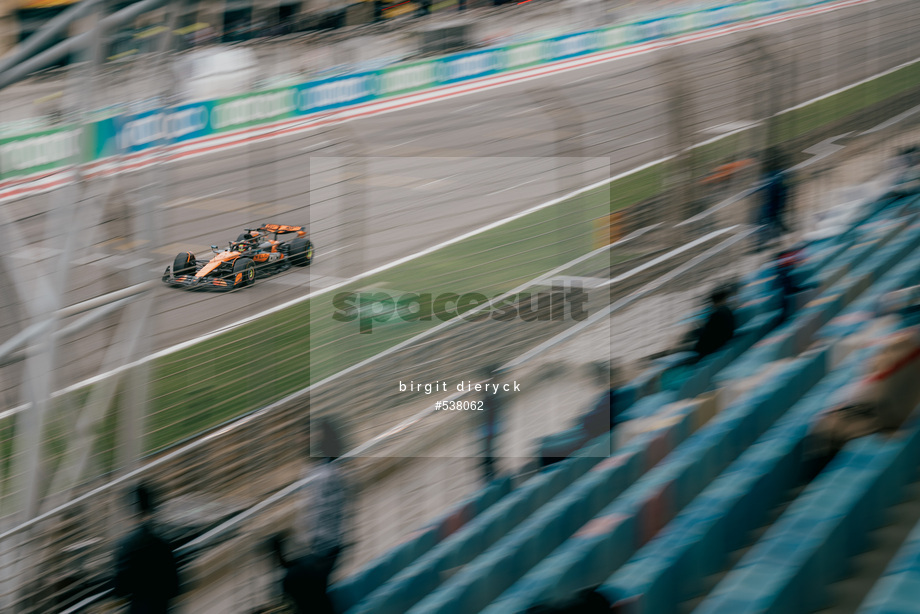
0;0;920;407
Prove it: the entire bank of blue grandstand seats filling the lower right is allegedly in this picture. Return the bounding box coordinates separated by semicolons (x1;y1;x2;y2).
333;189;920;614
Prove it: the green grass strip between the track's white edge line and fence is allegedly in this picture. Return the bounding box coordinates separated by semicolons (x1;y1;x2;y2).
0;56;920;510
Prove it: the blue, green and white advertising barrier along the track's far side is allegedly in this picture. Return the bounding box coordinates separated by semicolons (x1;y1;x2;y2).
0;0;835;180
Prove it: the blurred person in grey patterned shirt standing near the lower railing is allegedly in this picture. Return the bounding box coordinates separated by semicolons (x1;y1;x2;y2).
286;420;347;611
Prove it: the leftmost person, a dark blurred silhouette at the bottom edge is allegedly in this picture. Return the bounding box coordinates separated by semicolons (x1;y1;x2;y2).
114;484;179;614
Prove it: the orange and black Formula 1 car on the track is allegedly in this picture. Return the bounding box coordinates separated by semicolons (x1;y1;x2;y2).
163;224;313;291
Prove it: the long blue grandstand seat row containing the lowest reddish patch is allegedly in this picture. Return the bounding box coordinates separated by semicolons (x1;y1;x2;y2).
474;350;827;614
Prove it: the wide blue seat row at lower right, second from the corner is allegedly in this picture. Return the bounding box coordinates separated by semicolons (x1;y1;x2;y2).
697;412;920;614
